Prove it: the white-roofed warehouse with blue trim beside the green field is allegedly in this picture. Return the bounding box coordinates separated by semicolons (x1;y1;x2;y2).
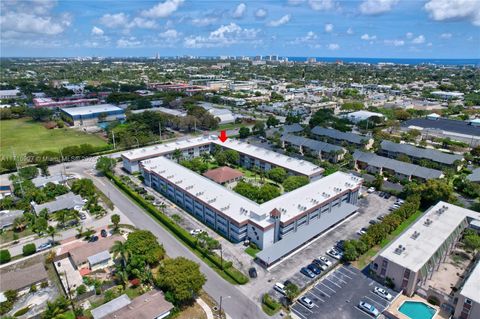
61;104;125;126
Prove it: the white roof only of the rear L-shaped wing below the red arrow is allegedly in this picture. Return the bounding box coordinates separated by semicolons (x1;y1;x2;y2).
122;135;323;176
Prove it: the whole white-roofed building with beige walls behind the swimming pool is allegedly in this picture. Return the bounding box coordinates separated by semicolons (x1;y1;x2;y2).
370;201;480;298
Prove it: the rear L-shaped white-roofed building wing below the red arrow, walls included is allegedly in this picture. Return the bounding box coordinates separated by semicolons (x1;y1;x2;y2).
122;136;324;180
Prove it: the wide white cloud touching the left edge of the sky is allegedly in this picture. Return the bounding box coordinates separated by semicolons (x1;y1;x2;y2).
0;11;72;35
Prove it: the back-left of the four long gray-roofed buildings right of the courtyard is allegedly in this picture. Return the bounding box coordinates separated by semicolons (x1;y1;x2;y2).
310;126;373;150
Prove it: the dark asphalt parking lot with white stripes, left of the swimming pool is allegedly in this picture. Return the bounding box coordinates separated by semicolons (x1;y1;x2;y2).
291;266;398;319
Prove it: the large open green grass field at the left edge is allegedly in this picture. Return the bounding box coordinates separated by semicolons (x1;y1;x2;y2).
0;119;107;157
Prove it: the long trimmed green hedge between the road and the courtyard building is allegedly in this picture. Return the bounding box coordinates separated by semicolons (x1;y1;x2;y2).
105;172;248;285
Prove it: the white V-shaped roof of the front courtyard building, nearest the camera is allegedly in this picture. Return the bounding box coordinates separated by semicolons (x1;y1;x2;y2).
142;157;361;227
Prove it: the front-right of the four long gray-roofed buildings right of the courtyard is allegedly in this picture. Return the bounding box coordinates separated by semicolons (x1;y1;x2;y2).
353;150;444;181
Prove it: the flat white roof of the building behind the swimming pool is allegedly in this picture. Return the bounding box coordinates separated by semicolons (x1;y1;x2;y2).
380;202;480;272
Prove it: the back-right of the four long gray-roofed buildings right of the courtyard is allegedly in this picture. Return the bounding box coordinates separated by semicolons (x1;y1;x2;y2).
378;140;463;170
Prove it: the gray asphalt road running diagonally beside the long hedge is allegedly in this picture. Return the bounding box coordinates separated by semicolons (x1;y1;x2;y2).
54;159;267;319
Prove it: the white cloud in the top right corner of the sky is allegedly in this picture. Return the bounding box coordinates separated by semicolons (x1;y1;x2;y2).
424;0;480;26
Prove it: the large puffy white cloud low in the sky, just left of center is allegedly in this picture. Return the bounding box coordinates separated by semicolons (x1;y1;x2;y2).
184;23;260;48
